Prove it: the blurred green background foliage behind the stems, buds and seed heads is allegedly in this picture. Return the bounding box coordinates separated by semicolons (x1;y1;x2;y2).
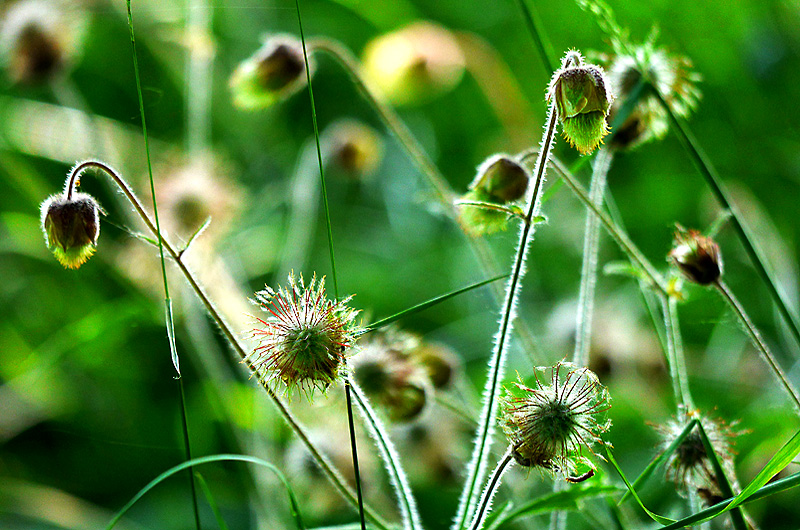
0;0;800;529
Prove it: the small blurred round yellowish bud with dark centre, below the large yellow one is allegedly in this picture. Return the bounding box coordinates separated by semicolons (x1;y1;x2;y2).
325;120;383;181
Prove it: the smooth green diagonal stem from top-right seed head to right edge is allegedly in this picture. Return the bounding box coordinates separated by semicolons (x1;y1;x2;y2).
652;89;800;352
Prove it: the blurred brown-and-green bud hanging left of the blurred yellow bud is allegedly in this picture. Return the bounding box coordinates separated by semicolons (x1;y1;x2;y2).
229;35;314;110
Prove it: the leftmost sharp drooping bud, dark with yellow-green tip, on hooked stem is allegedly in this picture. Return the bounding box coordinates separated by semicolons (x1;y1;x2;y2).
41;191;100;269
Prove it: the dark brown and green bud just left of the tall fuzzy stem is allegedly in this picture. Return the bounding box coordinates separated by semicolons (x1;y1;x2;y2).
457;154;530;236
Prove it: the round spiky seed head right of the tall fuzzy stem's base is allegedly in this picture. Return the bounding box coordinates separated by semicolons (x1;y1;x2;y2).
500;361;611;478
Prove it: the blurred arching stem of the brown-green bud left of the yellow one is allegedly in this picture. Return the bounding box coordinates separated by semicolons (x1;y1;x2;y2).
308;37;543;365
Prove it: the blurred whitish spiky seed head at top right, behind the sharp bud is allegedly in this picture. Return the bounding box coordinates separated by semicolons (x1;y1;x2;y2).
604;40;700;150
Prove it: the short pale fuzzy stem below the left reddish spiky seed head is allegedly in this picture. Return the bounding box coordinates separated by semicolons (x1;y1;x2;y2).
346;377;422;530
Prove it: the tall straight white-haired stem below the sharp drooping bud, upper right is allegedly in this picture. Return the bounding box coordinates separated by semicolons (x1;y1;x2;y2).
453;97;558;529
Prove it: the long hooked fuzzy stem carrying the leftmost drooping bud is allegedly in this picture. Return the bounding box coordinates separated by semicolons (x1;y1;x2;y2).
64;160;390;530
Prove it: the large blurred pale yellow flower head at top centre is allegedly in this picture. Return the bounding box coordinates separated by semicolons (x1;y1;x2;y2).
364;22;466;105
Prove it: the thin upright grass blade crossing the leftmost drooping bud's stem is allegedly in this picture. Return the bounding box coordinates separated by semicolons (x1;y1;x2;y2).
127;0;200;530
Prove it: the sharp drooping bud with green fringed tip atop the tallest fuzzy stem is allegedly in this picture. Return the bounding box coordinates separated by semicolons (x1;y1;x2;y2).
547;51;613;155
